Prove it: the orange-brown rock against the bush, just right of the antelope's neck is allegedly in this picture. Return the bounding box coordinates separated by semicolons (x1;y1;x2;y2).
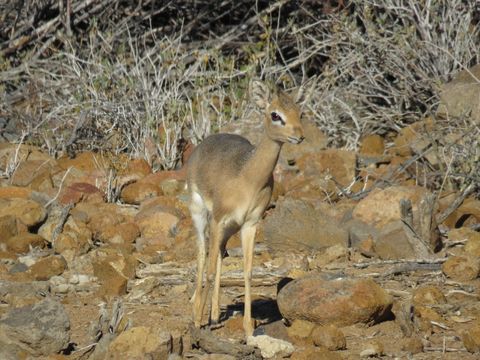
297;149;357;186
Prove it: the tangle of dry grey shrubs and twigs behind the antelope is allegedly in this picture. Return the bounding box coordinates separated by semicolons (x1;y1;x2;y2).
0;0;480;188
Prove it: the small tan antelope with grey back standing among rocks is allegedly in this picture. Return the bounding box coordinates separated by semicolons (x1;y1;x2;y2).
187;80;304;337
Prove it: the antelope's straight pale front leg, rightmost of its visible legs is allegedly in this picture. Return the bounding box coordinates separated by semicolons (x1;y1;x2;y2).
240;224;257;337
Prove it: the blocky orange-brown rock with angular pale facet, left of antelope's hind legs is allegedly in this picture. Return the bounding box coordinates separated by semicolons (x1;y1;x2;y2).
92;249;136;297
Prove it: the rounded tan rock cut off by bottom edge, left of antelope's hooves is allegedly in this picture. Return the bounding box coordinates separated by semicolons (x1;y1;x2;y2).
105;326;172;360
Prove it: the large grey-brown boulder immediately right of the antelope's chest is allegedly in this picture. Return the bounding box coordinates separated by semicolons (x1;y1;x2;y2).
262;198;348;255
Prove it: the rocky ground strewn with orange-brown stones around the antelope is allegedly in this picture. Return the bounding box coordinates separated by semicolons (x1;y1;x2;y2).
0;67;480;359
